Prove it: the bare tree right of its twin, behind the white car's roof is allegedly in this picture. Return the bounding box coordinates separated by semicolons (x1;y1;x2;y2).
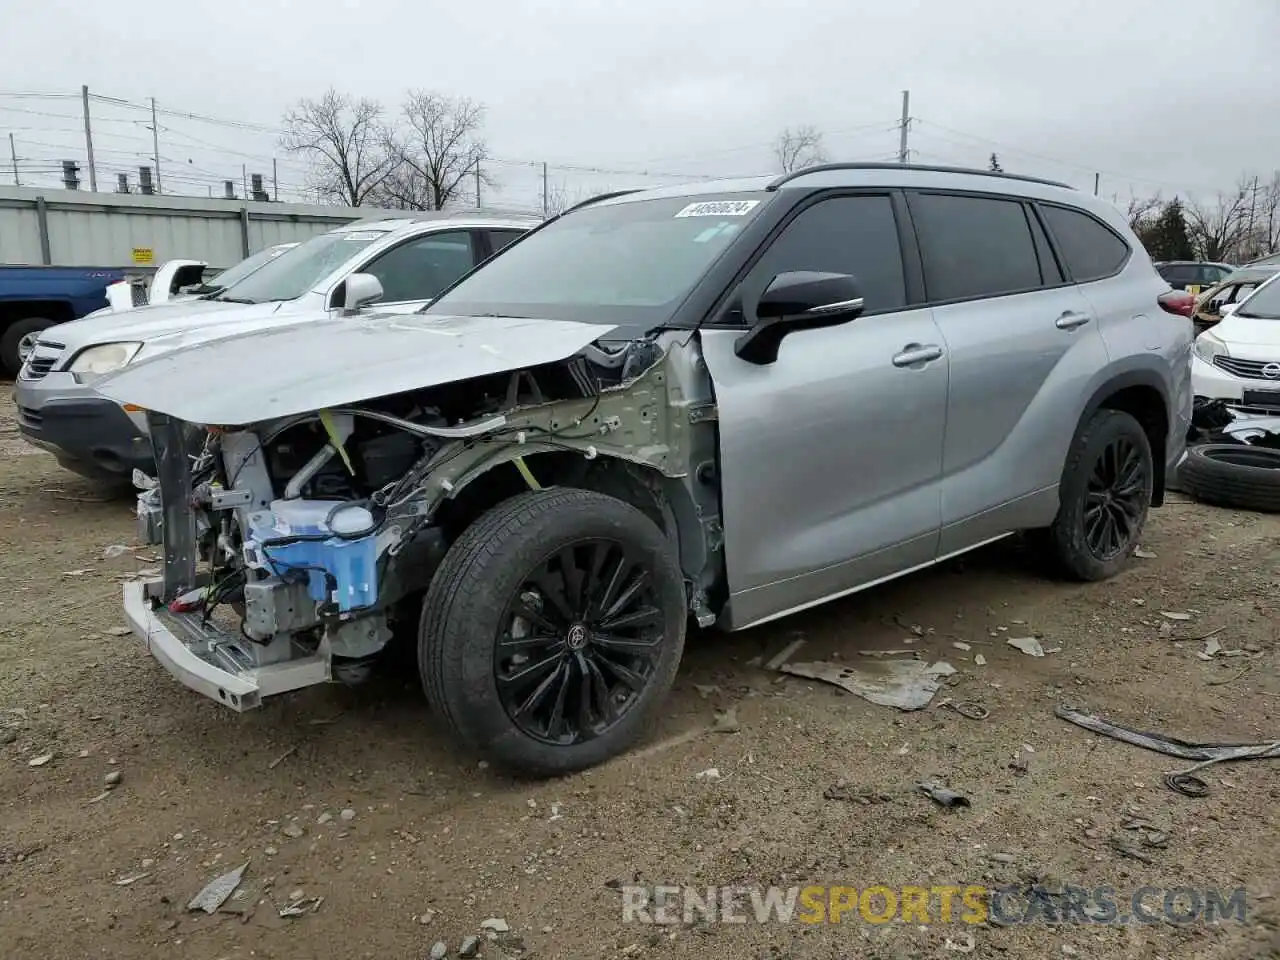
381;90;493;210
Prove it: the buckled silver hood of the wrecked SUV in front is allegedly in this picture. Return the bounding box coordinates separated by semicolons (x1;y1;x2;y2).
95;314;616;426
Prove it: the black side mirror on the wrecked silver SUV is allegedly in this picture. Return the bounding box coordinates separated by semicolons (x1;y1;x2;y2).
733;270;864;365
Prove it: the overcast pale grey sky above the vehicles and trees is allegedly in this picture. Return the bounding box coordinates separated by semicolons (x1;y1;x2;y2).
0;0;1280;207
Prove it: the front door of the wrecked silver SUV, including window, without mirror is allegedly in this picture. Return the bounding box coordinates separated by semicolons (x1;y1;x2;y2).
700;195;947;627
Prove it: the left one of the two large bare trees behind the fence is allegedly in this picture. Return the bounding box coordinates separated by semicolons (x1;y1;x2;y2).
280;87;393;206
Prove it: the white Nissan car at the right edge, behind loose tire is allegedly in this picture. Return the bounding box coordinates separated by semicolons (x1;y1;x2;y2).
1192;274;1280;415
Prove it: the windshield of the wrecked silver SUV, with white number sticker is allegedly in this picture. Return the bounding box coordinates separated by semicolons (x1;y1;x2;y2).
425;193;769;337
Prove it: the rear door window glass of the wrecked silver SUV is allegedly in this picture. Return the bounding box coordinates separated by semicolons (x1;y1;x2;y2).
910;193;1041;302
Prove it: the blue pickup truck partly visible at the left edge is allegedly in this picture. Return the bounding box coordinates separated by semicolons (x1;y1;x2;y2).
0;266;125;376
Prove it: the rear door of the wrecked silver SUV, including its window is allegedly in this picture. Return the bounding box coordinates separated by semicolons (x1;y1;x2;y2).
909;191;1106;556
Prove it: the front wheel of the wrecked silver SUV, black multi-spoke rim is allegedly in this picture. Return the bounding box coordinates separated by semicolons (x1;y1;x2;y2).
419;488;687;777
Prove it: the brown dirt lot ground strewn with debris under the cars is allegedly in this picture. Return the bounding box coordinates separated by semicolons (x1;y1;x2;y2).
0;388;1280;960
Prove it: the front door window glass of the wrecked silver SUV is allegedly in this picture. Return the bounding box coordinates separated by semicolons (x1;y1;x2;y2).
741;196;906;317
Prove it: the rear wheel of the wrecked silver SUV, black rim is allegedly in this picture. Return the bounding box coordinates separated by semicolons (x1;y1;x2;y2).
1038;410;1156;581
